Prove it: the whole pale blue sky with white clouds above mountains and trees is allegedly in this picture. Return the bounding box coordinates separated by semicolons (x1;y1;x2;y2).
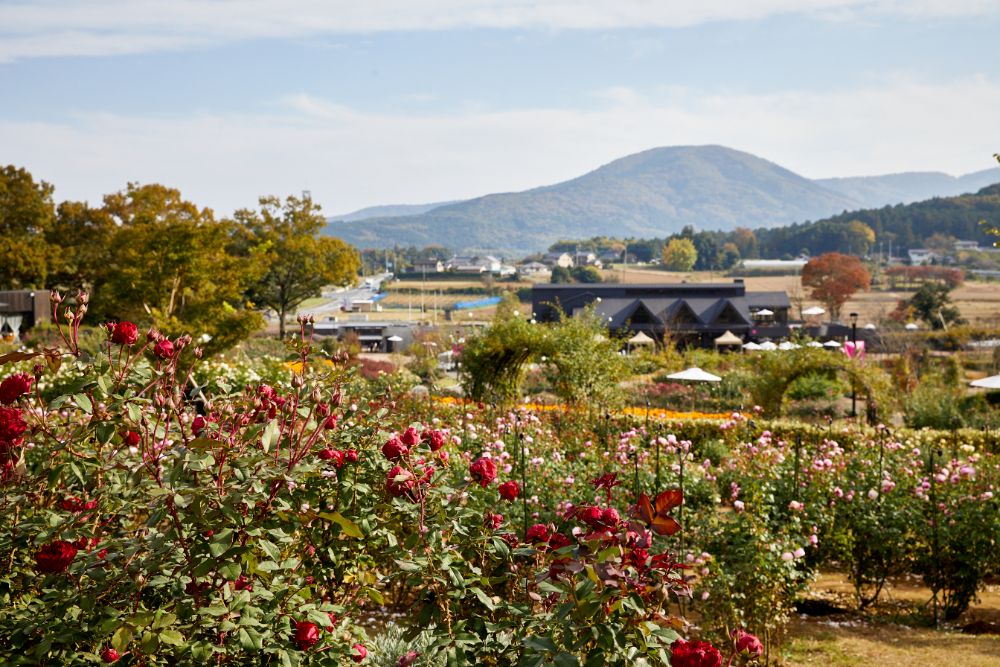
0;0;1000;215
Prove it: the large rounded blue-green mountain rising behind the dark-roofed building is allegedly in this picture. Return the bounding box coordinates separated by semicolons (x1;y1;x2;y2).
327;146;859;253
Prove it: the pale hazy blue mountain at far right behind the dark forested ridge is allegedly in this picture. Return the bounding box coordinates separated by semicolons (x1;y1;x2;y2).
814;169;1000;207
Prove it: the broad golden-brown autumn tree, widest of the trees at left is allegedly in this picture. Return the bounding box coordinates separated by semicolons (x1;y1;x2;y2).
93;183;262;351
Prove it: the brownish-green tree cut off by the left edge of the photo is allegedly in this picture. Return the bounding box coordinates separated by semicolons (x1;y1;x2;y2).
0;165;55;289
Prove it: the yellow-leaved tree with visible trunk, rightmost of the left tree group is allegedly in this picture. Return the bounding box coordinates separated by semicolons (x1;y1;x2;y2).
236;197;361;338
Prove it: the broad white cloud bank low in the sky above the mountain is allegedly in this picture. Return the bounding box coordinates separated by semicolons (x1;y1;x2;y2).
0;78;1000;214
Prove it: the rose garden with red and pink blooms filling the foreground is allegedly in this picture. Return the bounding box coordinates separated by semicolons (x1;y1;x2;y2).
0;294;1000;667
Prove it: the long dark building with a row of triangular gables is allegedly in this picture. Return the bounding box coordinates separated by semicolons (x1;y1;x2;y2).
531;280;791;347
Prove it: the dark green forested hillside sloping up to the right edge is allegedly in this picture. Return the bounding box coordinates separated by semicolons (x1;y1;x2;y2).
756;183;1000;257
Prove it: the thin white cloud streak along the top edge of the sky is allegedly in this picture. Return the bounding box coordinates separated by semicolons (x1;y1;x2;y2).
0;0;1000;62
